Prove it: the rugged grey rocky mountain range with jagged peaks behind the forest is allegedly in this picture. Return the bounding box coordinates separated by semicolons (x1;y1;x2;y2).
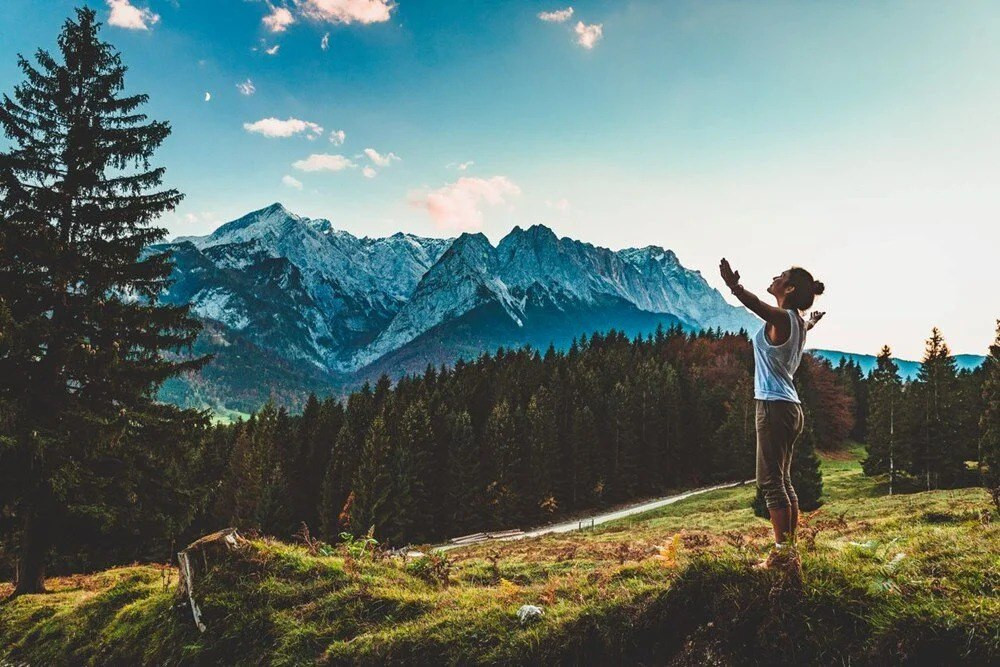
150;203;757;411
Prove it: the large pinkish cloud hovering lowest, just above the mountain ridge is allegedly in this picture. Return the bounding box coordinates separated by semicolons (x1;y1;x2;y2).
413;176;521;229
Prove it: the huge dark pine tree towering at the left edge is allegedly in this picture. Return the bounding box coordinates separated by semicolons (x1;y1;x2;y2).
0;8;199;594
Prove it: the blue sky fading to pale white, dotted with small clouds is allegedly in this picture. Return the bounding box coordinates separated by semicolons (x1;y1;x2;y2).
0;0;1000;359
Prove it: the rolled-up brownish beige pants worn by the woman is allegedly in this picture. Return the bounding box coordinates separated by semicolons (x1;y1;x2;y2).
757;399;805;509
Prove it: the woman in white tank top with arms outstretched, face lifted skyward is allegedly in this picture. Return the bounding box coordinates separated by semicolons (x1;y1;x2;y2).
719;258;824;568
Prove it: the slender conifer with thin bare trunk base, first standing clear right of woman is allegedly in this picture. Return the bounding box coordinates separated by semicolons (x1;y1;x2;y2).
861;345;908;495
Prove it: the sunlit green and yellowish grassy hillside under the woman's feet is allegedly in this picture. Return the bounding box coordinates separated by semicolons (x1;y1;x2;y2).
0;449;1000;665
